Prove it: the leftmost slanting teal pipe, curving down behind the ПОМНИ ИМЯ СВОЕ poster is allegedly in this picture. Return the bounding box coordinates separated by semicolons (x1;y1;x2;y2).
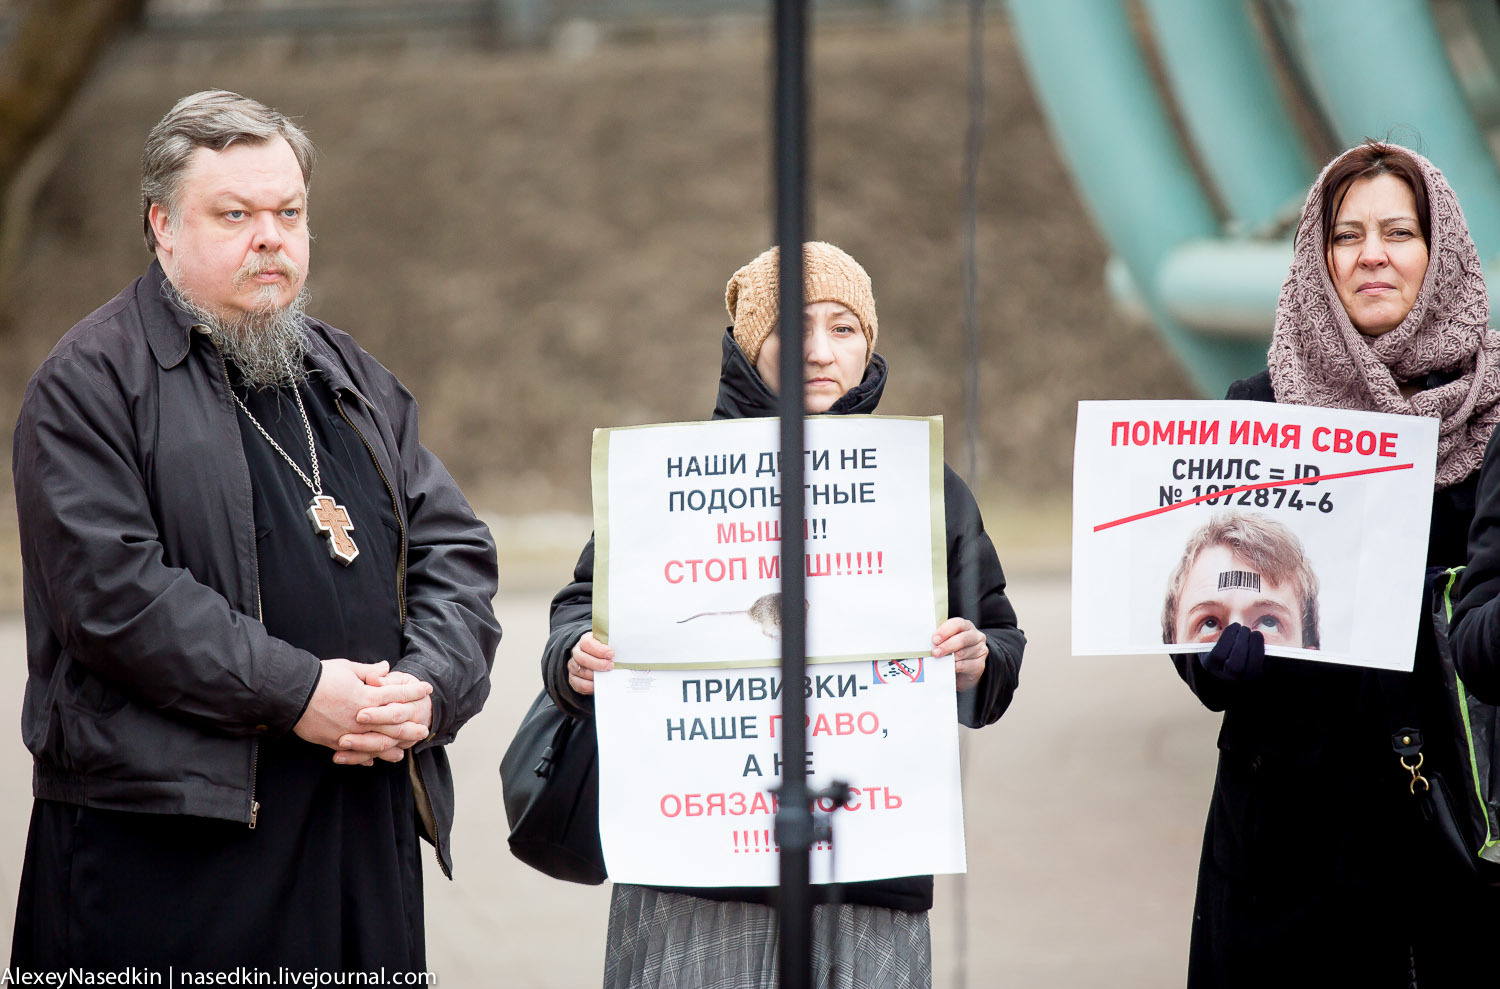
1010;0;1266;398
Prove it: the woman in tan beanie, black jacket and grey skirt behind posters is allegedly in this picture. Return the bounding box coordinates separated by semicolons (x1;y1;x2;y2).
542;243;1026;989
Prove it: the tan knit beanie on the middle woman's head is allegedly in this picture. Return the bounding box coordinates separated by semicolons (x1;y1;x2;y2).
725;240;879;365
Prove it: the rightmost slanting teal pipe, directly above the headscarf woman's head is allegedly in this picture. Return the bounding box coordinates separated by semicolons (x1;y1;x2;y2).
1290;0;1500;263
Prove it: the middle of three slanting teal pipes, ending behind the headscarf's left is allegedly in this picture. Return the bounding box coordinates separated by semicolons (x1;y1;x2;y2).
1145;0;1317;233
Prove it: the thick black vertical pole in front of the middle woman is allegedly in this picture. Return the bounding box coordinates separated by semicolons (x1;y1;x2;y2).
776;0;813;989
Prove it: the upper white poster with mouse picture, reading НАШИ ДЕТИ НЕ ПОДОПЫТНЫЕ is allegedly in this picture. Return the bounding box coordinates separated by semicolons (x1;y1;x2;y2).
594;416;948;666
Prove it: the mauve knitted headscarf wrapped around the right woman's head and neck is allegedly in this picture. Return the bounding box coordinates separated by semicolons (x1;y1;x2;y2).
1266;146;1500;488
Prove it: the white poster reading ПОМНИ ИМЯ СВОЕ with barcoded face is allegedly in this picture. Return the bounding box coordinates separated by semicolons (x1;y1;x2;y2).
1073;402;1437;671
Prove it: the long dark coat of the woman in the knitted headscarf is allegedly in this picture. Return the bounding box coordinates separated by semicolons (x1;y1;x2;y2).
1173;372;1500;989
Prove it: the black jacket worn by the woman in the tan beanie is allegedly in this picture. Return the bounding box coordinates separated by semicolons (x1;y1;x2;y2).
542;330;1026;911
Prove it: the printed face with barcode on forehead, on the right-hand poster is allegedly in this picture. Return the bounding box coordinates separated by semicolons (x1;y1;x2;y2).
1175;545;1302;647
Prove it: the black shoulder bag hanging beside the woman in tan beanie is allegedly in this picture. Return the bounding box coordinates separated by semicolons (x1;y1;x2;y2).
500;690;608;885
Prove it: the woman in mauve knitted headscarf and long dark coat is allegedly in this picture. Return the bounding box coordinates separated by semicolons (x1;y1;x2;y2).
1173;141;1500;989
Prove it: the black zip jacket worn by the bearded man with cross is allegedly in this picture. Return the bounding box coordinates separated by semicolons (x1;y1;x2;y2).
12;263;500;870
